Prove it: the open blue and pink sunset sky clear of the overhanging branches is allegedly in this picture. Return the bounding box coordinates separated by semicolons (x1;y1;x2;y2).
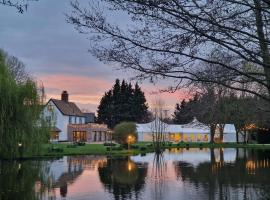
0;0;186;112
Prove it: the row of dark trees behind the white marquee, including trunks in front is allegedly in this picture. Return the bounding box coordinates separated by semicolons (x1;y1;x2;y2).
173;84;270;142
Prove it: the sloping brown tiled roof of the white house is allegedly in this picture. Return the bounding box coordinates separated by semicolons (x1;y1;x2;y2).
51;99;84;117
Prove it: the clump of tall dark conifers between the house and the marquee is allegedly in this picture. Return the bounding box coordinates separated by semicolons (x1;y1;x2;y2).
97;79;148;128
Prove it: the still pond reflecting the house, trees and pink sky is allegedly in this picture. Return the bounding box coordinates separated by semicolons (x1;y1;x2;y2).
0;149;270;200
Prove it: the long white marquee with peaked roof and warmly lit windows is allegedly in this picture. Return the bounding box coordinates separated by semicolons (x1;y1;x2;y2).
136;118;236;142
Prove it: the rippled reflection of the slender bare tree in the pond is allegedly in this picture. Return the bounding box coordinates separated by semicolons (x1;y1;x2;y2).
151;153;167;200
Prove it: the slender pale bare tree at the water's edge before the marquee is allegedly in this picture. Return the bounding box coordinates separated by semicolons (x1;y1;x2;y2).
150;99;167;153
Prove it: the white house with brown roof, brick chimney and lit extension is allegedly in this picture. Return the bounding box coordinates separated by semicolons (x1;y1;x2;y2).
43;91;111;142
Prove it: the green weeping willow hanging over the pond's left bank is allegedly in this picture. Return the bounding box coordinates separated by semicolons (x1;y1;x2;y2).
0;53;48;158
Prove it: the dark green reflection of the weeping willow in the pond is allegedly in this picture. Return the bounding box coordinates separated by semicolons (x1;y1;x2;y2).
0;160;49;200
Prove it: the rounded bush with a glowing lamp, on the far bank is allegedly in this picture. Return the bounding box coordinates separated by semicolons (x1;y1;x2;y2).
113;122;137;145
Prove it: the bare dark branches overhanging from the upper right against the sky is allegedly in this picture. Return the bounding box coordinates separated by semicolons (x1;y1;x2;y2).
67;0;270;101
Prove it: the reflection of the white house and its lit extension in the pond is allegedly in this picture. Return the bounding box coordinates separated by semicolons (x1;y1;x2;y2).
41;156;106;199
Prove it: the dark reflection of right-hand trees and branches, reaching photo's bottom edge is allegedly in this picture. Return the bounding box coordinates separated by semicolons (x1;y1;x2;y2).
174;149;270;199
